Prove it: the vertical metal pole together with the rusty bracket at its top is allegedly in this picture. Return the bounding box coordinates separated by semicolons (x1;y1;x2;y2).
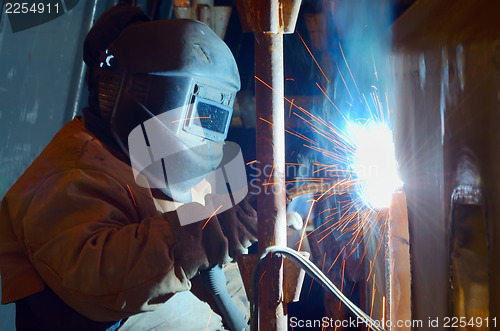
236;0;301;331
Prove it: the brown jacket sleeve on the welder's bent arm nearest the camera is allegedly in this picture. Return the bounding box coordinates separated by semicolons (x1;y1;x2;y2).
23;169;227;321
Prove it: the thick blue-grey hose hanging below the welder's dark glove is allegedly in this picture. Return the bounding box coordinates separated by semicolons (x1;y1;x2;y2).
200;265;248;331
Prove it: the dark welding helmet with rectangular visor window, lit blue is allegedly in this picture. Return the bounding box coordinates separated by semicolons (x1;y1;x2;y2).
99;19;240;202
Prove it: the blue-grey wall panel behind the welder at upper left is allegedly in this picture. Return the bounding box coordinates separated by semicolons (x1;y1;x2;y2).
0;1;116;331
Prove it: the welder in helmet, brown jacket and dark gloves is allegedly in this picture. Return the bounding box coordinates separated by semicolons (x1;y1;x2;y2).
0;3;257;330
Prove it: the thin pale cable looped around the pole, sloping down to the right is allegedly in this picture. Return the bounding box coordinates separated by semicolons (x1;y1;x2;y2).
250;246;385;331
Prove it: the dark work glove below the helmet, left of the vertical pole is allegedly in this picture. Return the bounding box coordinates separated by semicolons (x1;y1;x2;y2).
172;199;257;278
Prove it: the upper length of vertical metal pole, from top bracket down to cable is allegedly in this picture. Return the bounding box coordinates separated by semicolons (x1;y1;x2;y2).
255;27;286;254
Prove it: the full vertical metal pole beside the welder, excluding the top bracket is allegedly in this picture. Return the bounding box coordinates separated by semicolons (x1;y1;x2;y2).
255;32;287;331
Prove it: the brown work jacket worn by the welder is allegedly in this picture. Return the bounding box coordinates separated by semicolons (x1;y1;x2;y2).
0;118;193;321
